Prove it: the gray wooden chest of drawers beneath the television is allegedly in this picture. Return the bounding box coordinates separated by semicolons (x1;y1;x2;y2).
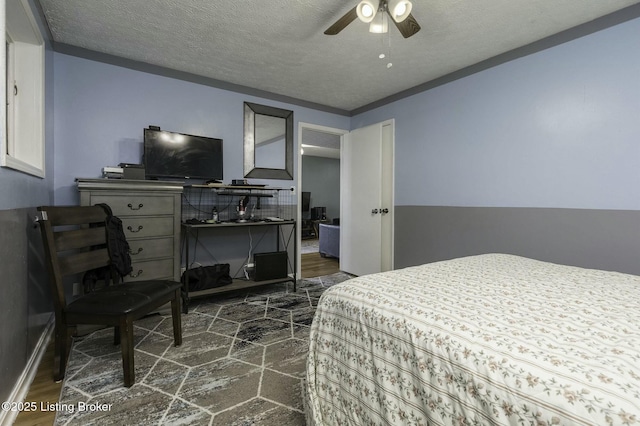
76;179;183;281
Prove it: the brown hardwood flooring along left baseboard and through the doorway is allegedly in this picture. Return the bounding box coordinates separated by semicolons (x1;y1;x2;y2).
14;253;340;426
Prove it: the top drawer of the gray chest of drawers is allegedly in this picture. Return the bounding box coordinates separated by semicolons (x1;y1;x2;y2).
91;194;174;217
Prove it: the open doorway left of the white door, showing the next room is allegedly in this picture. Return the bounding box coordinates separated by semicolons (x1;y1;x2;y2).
297;123;348;278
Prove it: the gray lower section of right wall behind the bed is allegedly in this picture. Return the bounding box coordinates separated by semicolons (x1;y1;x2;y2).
395;206;640;275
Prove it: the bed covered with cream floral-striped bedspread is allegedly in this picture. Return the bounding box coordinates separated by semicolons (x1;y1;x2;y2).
305;254;640;426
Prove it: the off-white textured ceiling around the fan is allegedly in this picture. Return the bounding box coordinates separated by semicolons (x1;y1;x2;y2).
40;0;640;111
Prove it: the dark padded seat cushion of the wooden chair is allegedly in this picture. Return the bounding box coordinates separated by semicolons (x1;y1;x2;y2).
66;280;181;315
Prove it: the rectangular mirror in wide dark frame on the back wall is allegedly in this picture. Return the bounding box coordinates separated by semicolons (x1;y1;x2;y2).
244;102;293;180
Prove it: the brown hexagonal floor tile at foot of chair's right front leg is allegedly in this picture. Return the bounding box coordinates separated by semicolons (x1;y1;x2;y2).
164;333;233;367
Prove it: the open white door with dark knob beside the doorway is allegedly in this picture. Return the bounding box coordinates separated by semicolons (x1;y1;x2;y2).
340;120;394;276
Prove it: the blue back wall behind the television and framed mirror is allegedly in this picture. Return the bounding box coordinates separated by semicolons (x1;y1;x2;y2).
54;53;349;204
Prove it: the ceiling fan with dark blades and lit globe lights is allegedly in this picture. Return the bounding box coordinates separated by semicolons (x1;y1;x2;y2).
324;0;420;38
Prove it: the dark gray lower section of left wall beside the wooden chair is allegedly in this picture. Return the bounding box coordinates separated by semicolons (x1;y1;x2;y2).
0;208;53;401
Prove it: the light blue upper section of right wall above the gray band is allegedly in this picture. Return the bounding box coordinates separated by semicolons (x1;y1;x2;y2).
351;19;640;210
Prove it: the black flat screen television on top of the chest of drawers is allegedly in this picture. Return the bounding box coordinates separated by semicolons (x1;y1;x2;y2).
143;128;223;180
